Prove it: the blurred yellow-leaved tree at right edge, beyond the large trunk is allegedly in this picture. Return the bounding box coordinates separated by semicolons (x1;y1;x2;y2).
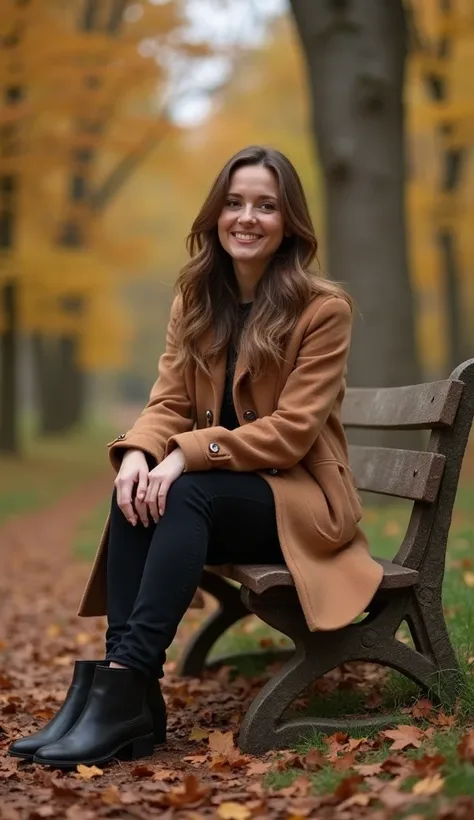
407;0;474;373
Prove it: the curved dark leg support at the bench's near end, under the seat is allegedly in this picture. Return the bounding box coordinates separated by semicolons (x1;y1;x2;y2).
239;588;460;754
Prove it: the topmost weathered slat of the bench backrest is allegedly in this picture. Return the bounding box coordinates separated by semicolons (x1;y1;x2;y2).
342;379;464;430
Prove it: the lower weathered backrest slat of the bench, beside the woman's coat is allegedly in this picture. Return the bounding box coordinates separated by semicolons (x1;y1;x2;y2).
349;445;445;502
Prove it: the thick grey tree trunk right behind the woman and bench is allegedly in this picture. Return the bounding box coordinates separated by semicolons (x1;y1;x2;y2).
291;0;420;410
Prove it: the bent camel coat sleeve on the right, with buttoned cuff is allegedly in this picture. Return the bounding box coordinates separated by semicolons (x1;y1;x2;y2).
165;297;352;472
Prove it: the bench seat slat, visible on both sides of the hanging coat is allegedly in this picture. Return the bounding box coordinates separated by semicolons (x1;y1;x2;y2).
211;558;418;595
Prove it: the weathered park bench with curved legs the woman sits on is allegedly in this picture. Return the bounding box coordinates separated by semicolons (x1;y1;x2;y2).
180;359;474;754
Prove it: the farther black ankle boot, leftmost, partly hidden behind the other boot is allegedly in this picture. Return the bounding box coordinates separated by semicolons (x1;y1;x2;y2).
8;661;98;760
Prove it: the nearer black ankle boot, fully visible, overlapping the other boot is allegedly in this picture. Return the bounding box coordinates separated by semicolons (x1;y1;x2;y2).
33;665;154;769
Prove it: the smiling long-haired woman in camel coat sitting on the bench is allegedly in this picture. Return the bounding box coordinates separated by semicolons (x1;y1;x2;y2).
10;146;382;767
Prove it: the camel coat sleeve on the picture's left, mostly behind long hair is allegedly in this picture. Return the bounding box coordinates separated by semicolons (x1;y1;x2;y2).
109;297;194;470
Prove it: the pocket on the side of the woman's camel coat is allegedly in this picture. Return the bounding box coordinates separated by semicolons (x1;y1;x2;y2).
309;459;362;546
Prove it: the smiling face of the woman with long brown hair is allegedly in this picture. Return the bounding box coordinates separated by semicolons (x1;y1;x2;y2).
217;165;285;270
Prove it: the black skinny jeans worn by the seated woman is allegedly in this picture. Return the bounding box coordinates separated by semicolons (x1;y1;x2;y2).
106;470;285;677
